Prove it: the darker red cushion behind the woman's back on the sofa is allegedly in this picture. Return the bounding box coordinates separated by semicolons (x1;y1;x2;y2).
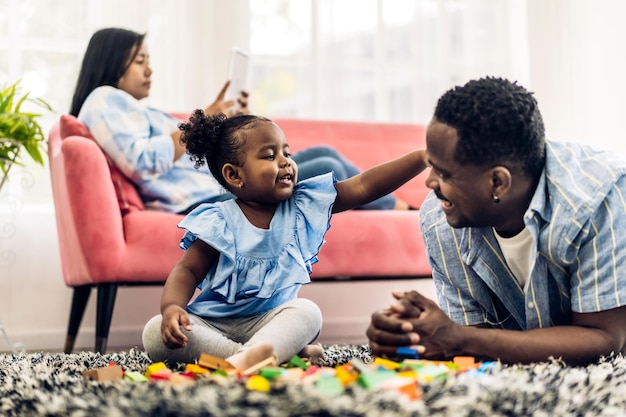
59;114;145;215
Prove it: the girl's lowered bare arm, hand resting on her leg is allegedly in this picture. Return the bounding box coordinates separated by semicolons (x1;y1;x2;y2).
161;240;219;349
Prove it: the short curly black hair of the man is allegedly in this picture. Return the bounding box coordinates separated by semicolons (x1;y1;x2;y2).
434;77;545;178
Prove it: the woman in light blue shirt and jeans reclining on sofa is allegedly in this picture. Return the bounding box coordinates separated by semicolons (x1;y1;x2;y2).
70;28;409;213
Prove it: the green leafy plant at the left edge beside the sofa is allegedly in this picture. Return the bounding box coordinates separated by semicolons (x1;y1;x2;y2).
0;81;52;189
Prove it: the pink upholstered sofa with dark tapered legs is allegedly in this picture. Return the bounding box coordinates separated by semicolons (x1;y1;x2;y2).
48;116;431;353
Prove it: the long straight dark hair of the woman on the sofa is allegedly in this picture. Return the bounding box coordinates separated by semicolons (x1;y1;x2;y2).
70;28;146;116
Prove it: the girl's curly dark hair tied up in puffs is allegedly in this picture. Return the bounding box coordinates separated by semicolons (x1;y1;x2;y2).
178;109;271;189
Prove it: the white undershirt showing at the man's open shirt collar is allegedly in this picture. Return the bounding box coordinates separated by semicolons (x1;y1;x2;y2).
493;227;533;292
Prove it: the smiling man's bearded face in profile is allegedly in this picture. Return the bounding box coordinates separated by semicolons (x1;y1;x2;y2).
426;118;495;228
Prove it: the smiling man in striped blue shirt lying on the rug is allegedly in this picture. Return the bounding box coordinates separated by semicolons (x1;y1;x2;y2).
367;77;626;364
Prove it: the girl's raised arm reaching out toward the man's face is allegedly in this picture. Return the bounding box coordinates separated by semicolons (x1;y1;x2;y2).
333;149;428;213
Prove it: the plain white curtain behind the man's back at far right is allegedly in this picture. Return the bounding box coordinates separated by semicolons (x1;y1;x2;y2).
528;0;626;154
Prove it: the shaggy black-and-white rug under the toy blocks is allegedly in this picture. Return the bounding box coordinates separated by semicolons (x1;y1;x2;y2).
0;345;626;417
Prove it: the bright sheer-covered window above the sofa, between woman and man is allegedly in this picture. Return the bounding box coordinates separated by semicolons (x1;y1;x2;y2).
250;0;527;123
